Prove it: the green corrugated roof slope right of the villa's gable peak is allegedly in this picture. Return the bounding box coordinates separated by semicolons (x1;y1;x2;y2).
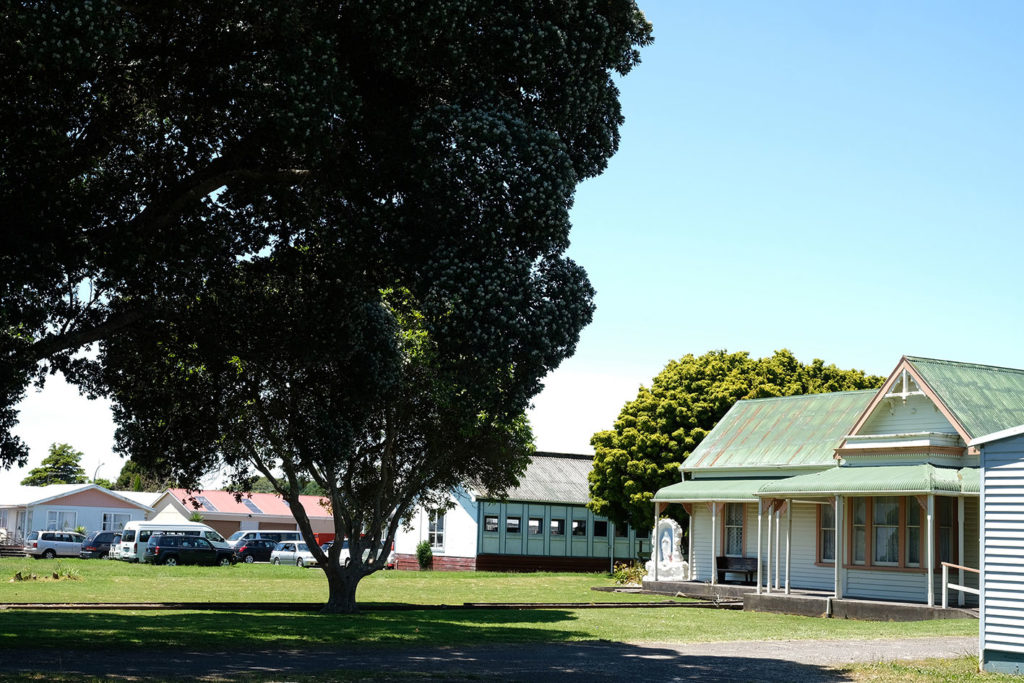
906;355;1024;438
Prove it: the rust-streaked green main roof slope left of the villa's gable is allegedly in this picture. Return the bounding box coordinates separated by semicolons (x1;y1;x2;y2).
684;390;877;469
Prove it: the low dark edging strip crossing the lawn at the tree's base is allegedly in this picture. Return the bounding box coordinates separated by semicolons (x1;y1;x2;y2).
0;600;742;612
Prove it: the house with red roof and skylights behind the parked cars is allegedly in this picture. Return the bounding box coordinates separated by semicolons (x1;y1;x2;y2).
151;488;334;539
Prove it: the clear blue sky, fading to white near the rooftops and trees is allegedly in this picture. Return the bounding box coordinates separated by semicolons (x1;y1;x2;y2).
9;0;1024;485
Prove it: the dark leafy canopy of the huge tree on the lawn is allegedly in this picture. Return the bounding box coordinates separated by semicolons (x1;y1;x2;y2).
0;0;650;600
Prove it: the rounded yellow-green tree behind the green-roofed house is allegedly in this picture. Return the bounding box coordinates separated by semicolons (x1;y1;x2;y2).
588;349;885;531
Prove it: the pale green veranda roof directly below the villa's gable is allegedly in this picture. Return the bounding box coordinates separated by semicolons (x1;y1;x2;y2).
758;464;978;498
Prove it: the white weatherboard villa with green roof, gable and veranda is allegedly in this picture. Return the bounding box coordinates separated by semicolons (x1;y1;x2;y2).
645;356;1024;613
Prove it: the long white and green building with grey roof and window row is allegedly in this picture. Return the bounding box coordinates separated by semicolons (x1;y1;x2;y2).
395;453;649;571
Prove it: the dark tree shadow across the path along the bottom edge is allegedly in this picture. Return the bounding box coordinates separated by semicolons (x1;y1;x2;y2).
0;643;850;683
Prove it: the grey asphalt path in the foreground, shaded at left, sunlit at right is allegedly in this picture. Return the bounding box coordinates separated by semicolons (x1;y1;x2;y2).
0;636;978;683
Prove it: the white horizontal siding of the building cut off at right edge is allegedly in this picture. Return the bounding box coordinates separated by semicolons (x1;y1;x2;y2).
980;436;1024;652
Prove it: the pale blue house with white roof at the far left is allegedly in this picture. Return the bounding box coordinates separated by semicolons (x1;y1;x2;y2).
0;483;159;544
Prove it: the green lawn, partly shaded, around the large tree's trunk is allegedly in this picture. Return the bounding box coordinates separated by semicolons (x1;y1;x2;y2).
0;559;978;650
